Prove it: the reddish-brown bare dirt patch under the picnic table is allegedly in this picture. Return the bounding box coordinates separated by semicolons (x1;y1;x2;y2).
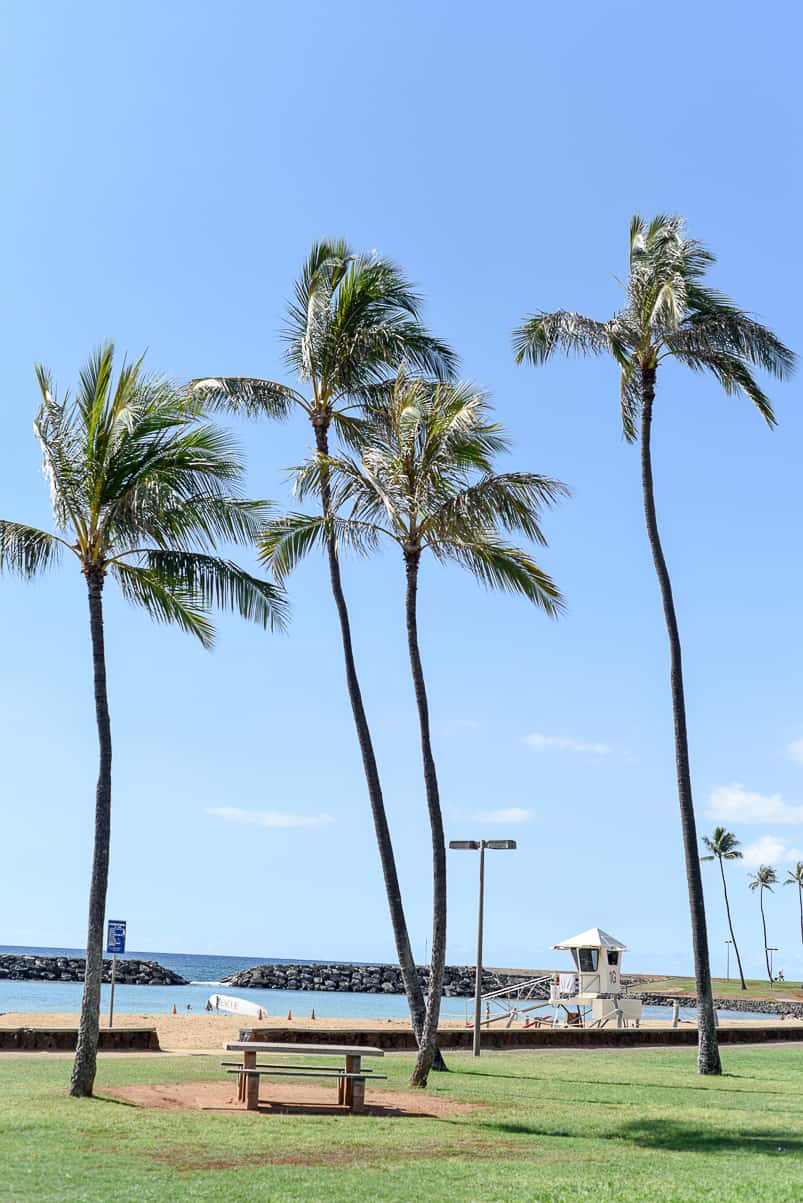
104;1081;484;1119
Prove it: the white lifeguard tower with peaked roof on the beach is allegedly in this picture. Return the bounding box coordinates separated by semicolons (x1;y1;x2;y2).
549;928;642;1027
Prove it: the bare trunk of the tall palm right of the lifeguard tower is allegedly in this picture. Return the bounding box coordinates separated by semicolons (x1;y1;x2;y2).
642;367;722;1073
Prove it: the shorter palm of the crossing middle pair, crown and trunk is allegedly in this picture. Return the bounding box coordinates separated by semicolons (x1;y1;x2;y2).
261;368;567;1086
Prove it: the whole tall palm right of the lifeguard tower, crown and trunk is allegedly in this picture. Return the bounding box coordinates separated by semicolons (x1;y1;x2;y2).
514;215;795;1073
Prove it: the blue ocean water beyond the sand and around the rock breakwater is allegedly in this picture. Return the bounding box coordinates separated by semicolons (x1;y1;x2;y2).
0;944;770;1026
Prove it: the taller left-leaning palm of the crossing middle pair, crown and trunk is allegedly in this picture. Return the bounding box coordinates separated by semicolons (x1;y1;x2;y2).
194;241;456;1053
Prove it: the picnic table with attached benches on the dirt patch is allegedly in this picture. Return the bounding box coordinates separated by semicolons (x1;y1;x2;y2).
220;1041;386;1112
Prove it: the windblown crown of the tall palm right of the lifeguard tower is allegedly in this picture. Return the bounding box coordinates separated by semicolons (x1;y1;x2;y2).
514;214;796;439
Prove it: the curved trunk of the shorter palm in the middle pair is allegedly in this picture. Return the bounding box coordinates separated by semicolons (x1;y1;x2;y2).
405;547;447;1086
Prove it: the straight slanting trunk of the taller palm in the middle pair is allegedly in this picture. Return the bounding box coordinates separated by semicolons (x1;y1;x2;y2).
313;422;445;1068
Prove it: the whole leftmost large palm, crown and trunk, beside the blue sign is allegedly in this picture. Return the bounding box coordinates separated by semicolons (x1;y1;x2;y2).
0;343;285;1096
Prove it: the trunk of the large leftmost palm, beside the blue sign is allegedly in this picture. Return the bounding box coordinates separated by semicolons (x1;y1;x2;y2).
70;569;112;1098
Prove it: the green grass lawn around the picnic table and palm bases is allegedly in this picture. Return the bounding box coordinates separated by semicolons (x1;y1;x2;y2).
0;1045;803;1203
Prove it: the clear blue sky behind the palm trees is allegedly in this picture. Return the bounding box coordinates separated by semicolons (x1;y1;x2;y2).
0;0;803;977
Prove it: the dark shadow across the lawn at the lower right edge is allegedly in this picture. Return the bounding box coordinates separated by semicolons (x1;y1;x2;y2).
485;1120;803;1157
